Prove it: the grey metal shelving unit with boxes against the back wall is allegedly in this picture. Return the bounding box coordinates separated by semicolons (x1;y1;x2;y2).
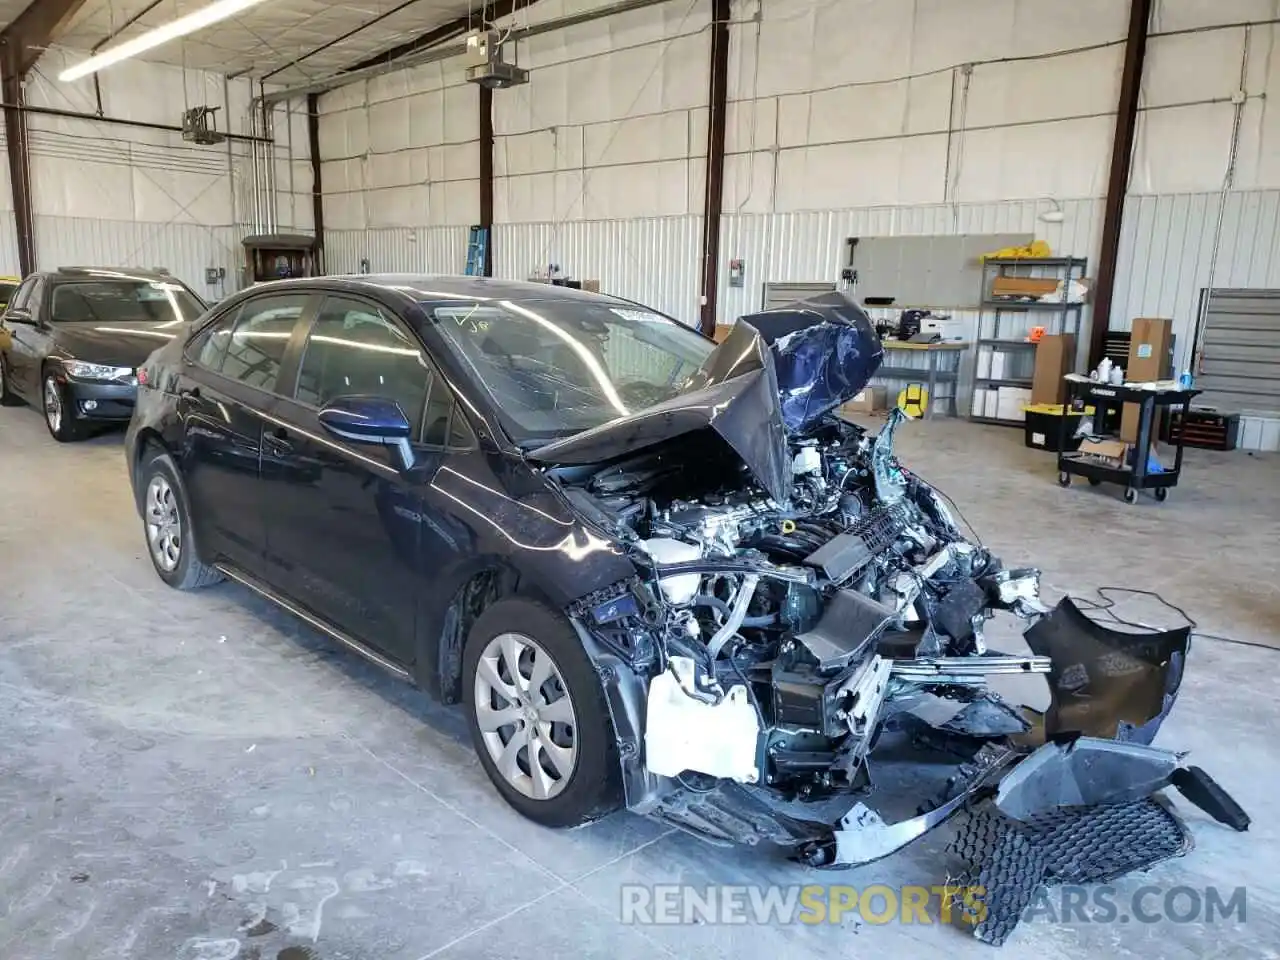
969;257;1088;426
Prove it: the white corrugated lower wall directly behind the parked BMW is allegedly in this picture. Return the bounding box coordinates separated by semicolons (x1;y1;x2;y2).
33;214;243;300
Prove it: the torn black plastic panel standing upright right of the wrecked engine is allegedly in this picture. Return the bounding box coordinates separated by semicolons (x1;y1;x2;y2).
1023;596;1190;744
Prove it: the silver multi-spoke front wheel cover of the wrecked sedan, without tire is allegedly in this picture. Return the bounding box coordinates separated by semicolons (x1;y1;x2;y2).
475;634;579;800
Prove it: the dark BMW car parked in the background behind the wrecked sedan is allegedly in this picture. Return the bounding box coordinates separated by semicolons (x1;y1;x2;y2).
0;268;205;443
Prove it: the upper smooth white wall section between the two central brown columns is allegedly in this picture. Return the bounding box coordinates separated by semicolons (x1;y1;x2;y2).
493;0;710;225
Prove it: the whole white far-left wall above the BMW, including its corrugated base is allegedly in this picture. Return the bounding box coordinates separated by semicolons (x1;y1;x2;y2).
14;47;311;297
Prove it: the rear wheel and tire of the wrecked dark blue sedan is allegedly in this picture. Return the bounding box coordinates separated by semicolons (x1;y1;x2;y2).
136;447;223;590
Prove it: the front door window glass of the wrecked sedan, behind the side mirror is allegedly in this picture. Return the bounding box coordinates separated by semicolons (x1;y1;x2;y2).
297;297;430;424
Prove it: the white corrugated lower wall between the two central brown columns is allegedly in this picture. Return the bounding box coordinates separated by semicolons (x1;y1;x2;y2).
493;216;703;324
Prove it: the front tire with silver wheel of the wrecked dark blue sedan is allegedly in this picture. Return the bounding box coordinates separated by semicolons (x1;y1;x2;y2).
462;598;622;827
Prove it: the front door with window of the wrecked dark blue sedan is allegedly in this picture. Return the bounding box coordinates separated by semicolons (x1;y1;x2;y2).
262;296;431;664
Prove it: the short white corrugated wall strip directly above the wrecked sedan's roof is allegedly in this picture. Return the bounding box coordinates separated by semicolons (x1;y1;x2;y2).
324;227;467;274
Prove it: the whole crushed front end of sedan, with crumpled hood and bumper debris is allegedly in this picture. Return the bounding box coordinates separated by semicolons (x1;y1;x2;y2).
534;294;1248;942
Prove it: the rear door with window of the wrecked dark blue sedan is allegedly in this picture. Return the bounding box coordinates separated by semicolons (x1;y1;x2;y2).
178;293;311;576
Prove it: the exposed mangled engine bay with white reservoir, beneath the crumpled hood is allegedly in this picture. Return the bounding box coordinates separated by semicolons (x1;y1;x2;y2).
563;413;1050;799
